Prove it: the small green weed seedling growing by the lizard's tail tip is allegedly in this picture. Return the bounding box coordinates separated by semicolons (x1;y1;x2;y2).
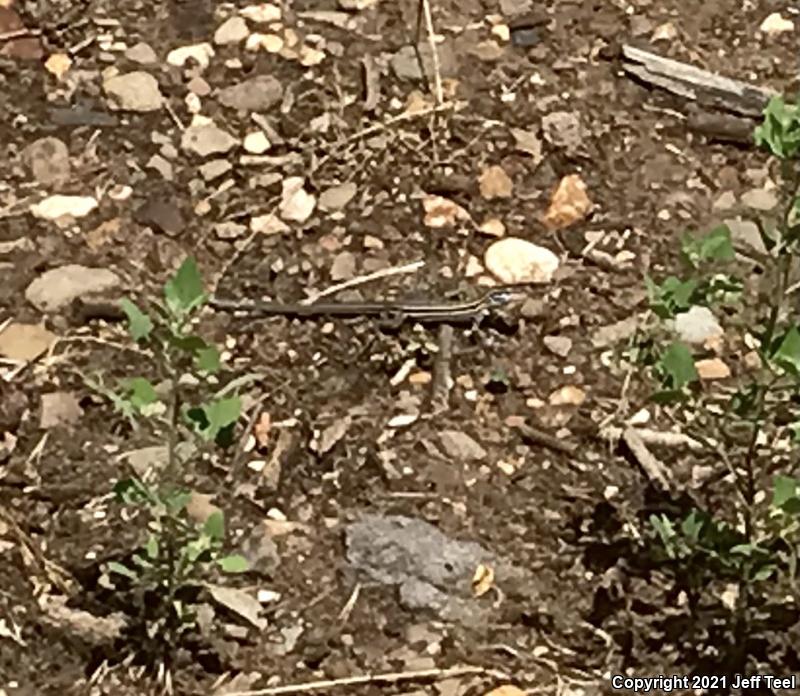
92;258;247;650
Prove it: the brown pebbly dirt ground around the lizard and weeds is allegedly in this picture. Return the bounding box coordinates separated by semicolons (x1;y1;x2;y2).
0;0;800;696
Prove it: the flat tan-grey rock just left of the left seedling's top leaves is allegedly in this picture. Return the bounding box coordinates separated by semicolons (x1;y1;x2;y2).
25;264;121;312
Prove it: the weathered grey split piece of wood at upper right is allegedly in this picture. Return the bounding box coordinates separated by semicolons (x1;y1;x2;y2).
622;45;776;118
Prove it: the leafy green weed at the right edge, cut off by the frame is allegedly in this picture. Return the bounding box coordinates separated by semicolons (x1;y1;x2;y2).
629;97;800;667
